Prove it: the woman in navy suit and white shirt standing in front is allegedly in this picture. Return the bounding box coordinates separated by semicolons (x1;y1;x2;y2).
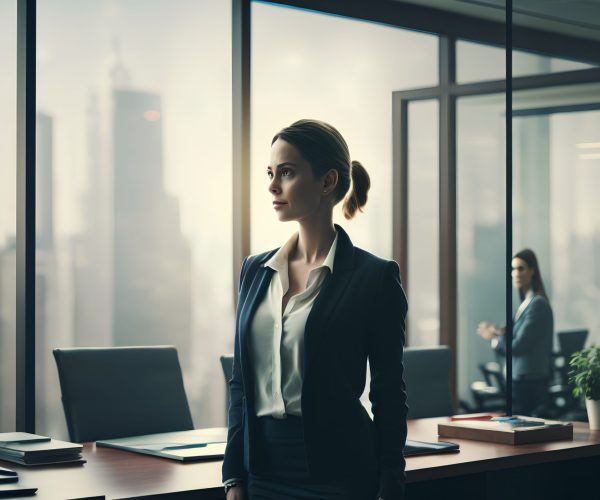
223;120;408;500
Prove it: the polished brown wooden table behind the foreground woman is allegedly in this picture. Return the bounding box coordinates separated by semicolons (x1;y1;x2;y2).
0;417;600;500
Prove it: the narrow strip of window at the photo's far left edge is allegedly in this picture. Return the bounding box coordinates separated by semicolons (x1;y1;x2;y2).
0;0;17;431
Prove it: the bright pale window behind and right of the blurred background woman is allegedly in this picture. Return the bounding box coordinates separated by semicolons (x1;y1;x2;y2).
513;101;600;344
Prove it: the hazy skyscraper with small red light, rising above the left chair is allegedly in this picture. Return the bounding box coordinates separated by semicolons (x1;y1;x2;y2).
112;89;191;366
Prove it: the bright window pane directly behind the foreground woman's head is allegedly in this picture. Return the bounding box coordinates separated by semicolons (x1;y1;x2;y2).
251;3;438;258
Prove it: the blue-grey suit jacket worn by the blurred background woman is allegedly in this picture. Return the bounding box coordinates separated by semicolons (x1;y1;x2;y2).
496;295;554;380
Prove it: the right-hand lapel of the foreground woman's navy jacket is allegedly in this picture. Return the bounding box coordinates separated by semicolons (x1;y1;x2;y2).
302;224;354;373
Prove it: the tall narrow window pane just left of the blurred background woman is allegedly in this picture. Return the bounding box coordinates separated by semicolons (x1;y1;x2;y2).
456;94;506;401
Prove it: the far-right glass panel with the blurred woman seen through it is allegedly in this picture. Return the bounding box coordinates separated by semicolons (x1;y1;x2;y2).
512;0;600;420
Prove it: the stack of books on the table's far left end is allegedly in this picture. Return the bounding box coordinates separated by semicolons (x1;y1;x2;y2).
0;432;85;465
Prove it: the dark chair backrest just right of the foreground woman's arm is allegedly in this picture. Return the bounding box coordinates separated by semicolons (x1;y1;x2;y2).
404;346;454;418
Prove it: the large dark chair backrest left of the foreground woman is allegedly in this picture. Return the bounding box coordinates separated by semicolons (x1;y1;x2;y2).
53;346;194;442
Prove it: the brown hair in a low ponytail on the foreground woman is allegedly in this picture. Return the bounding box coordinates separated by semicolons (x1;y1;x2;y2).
271;120;371;219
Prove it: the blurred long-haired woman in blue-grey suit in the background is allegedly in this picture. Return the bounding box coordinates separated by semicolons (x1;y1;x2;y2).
477;249;554;416
